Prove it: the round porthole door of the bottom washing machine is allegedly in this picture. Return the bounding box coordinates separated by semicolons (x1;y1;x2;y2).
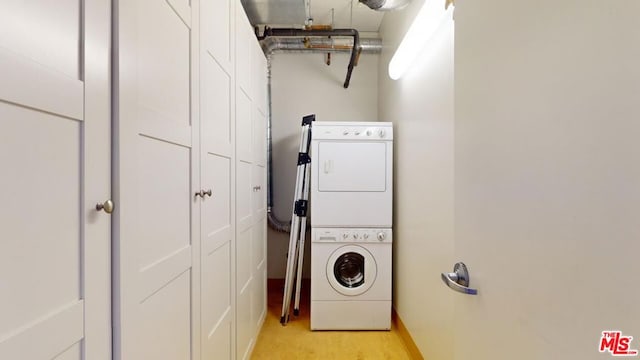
327;245;378;296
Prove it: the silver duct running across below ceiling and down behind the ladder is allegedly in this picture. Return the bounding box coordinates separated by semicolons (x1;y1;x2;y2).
260;35;382;233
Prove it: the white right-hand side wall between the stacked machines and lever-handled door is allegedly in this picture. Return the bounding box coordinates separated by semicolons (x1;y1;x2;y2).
379;1;454;360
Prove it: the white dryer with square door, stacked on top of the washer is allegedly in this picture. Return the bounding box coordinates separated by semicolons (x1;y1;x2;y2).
311;121;393;228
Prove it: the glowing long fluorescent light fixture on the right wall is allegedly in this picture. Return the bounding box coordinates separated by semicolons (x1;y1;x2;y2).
389;0;453;80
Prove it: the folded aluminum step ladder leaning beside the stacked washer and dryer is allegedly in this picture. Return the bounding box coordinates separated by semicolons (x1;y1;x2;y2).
280;115;316;325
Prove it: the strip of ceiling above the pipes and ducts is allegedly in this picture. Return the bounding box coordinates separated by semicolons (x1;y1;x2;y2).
242;0;384;32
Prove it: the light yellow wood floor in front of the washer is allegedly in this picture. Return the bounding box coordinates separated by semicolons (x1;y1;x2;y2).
251;280;411;360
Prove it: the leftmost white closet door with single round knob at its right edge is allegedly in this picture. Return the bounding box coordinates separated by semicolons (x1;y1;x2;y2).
0;0;111;359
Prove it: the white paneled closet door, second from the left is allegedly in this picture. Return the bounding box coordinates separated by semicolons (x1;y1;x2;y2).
114;0;198;360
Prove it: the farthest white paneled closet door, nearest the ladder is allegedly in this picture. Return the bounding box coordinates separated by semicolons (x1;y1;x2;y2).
235;8;267;358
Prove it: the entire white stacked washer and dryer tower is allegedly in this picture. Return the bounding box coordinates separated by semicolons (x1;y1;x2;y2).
311;122;393;330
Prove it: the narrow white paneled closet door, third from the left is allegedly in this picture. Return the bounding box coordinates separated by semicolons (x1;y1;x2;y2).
200;0;235;359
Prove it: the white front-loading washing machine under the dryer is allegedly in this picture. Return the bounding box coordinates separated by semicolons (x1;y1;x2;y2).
311;228;392;330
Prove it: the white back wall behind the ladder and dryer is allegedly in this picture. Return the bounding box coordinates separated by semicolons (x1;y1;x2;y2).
268;53;379;279
